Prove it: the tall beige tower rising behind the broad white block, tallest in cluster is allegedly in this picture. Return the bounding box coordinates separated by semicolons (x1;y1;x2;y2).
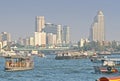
35;16;45;32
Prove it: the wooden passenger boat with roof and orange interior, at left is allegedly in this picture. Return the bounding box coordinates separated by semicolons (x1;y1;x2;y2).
5;55;34;71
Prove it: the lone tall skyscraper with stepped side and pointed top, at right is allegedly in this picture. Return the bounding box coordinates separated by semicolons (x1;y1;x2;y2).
90;11;105;42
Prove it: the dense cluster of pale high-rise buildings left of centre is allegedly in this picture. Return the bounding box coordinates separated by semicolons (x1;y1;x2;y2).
33;16;70;47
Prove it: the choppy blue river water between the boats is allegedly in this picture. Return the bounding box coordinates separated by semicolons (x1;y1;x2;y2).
0;55;120;81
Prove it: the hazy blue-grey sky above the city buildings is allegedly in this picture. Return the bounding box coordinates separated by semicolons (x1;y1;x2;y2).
0;0;120;41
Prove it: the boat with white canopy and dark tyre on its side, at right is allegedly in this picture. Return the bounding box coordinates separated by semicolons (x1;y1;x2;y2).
94;58;120;73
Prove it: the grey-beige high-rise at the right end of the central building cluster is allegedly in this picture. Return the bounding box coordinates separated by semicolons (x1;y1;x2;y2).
62;26;70;44
